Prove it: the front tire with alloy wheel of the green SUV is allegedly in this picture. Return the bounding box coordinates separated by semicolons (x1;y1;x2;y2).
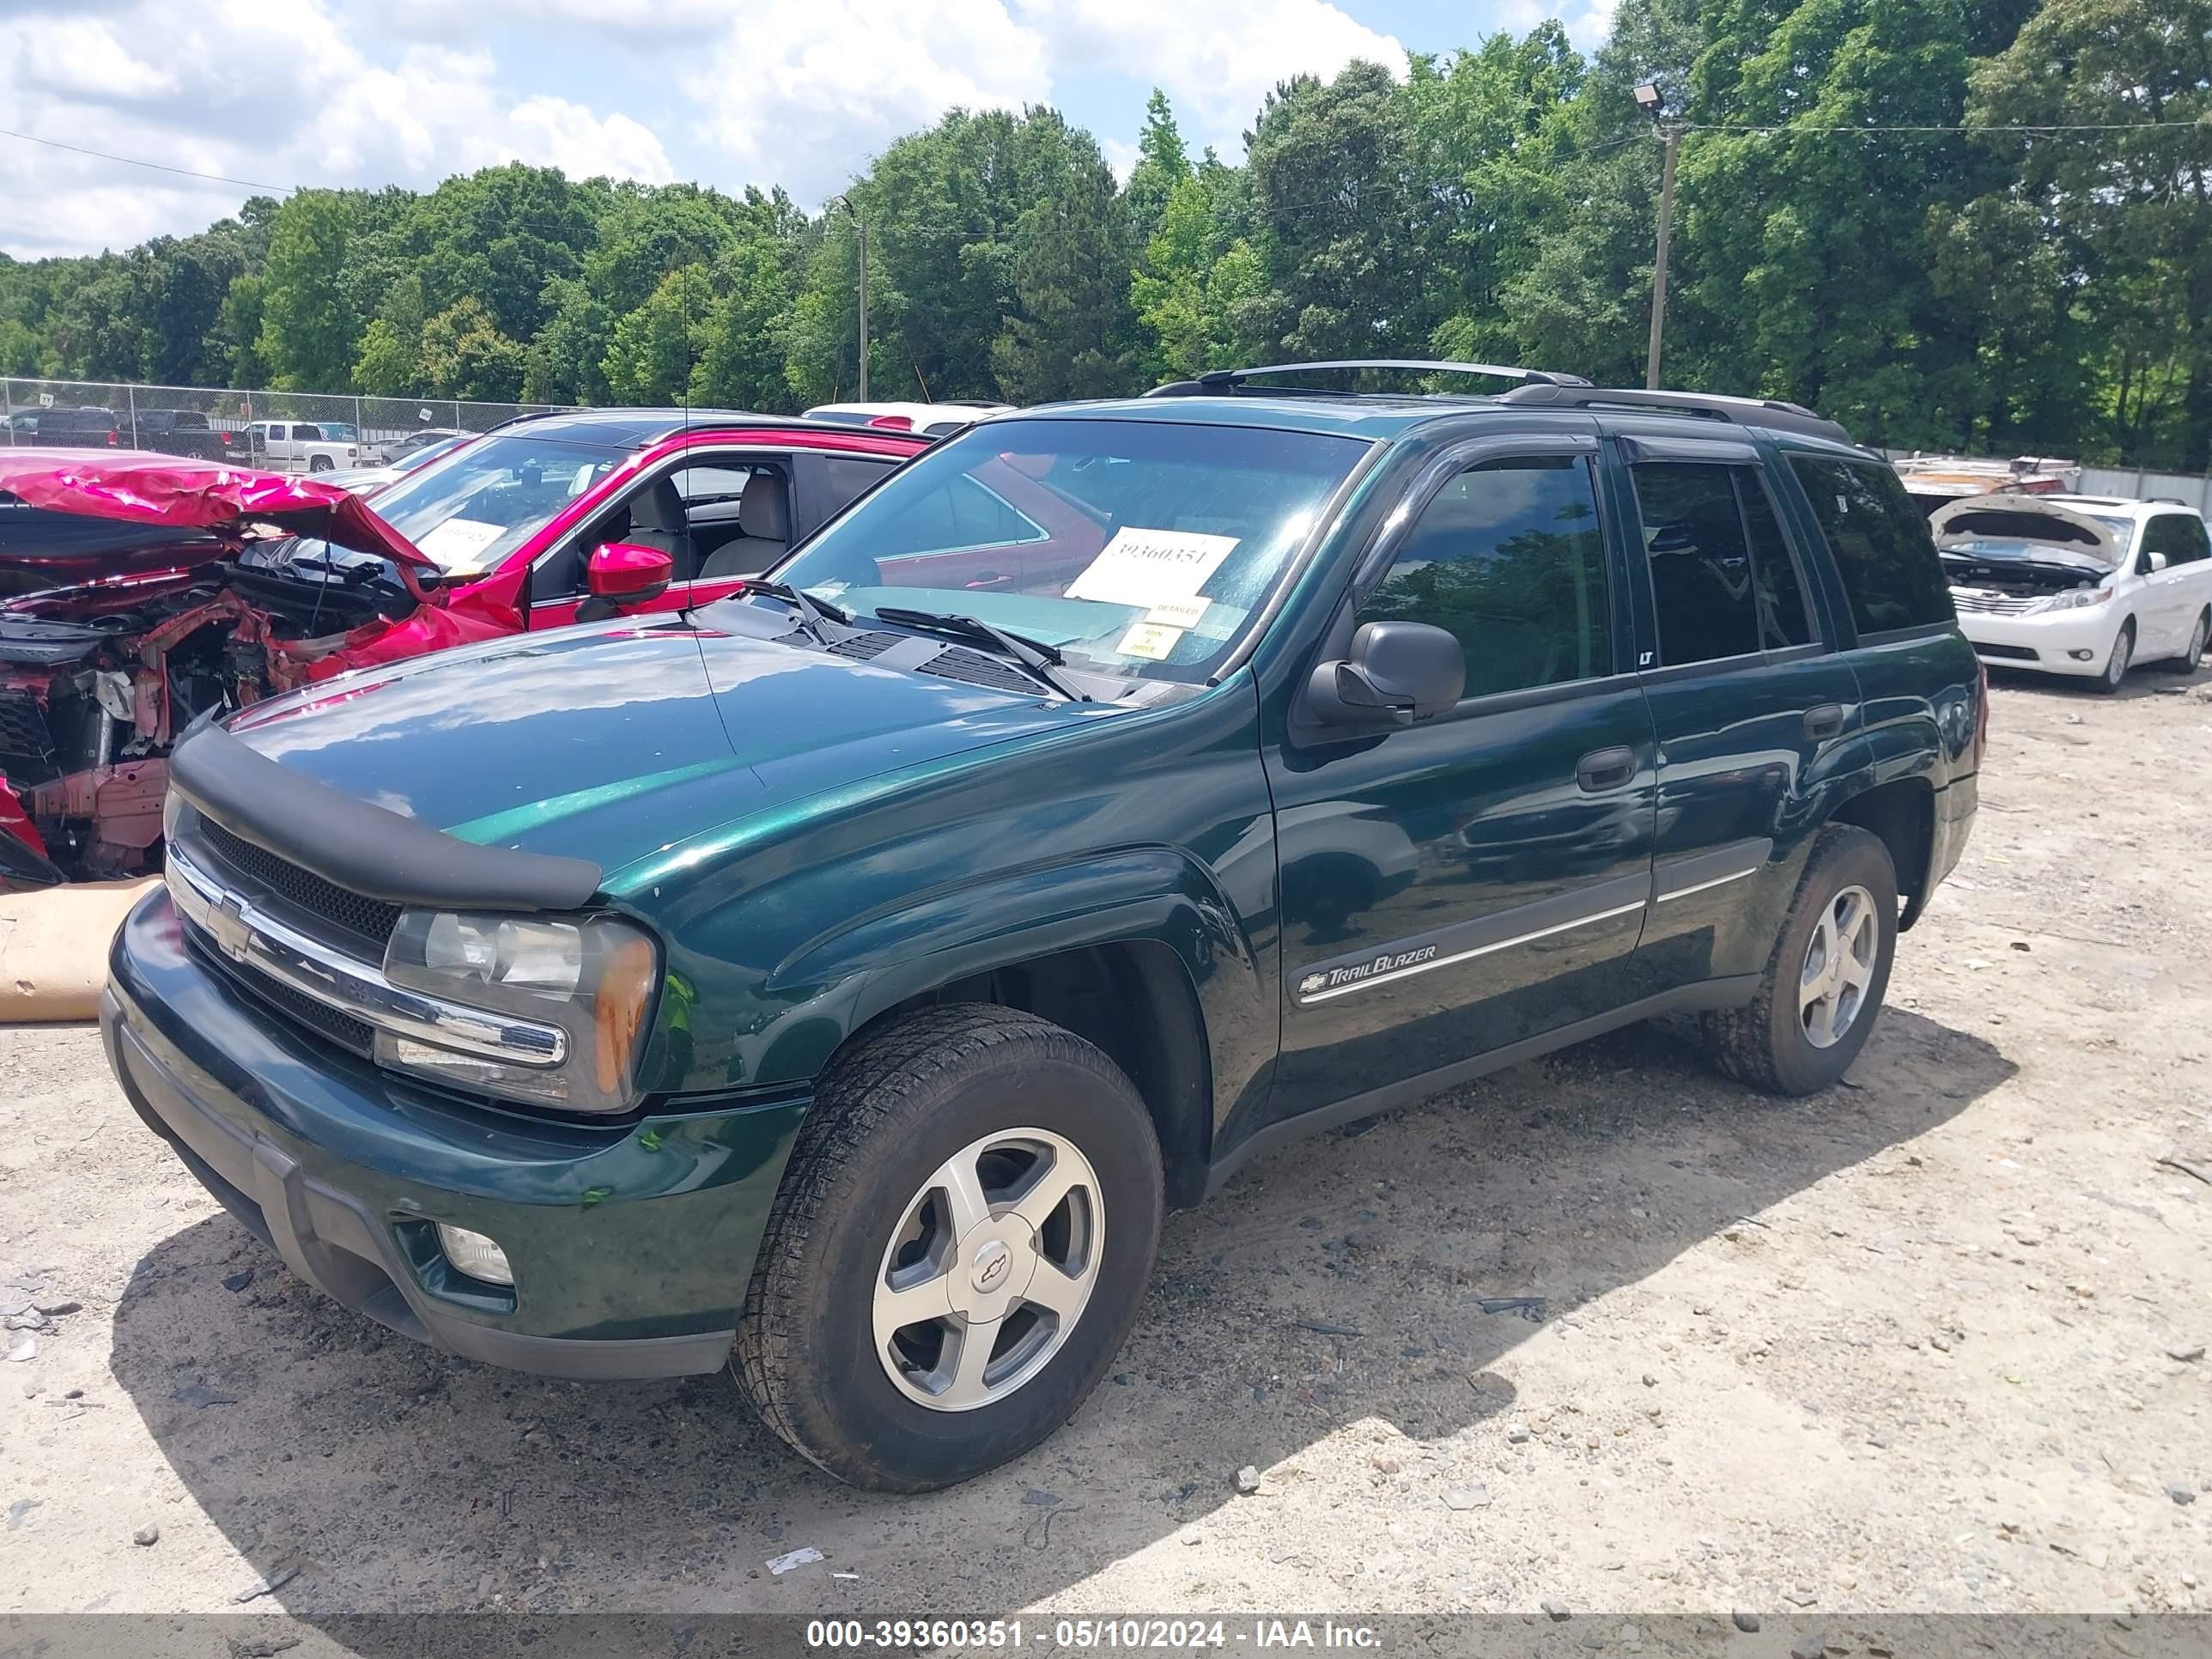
732;1002;1164;1493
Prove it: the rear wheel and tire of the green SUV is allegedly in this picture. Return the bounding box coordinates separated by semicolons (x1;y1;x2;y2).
1704;823;1898;1095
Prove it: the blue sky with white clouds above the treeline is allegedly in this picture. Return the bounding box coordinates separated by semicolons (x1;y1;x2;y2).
0;0;1613;257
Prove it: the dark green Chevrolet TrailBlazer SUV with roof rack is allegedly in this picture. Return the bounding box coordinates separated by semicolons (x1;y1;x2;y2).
101;365;1984;1491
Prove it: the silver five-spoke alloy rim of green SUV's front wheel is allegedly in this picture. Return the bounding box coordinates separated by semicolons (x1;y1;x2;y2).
874;1128;1106;1411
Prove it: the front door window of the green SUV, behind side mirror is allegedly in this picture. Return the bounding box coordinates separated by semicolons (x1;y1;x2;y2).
1358;458;1613;696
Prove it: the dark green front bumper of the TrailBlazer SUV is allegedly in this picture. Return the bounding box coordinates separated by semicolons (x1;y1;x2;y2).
100;891;805;1378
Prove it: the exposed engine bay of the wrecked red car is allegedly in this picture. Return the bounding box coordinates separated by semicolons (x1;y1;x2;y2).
0;555;418;884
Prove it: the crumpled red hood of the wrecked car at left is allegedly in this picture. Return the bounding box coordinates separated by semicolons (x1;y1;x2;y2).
0;449;438;571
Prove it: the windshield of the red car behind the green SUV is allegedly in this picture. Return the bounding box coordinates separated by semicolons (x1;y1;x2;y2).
354;434;629;575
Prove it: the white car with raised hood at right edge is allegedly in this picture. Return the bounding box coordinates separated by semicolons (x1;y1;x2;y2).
1929;495;2212;692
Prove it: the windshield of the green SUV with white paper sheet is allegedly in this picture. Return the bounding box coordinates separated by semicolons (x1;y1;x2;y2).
775;420;1367;681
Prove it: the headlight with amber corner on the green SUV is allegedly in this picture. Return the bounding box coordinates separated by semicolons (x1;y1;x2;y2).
376;909;661;1113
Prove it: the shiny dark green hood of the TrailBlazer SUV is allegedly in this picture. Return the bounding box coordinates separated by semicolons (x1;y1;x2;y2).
228;617;1110;874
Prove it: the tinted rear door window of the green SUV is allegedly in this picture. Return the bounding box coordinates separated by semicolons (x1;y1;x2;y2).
1632;460;1812;668
